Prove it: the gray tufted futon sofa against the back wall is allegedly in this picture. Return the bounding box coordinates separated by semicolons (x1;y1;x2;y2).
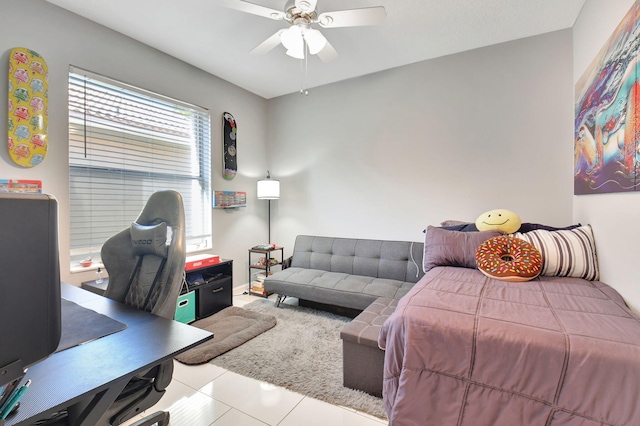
264;235;424;311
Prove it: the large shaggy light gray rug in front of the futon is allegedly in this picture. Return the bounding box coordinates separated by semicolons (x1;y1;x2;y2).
211;299;386;419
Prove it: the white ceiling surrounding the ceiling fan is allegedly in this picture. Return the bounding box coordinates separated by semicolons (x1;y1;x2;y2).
47;0;585;99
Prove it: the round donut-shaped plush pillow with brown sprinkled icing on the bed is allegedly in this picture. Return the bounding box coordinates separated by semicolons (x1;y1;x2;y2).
476;235;542;281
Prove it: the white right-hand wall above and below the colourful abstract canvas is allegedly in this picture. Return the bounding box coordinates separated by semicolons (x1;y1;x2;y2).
573;0;640;311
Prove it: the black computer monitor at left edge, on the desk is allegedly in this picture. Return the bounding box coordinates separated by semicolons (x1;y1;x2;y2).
0;193;61;386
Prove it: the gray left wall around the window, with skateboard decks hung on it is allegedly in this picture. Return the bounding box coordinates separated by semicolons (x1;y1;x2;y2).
0;0;267;285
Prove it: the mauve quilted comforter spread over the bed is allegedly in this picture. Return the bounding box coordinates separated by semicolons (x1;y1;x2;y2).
379;266;640;426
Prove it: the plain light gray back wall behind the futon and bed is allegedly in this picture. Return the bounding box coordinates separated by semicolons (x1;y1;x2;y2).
268;30;573;254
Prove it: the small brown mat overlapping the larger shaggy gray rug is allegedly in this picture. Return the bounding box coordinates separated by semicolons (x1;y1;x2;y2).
176;306;276;365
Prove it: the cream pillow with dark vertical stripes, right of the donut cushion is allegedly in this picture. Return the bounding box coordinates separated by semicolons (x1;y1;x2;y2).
513;225;600;281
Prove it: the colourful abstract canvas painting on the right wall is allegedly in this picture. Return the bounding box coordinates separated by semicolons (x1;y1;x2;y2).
574;2;640;195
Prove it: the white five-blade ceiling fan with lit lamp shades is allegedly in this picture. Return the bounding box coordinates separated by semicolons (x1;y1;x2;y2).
222;0;386;62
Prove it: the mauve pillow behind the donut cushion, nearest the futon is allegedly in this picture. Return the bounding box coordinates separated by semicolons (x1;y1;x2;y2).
422;226;502;272
